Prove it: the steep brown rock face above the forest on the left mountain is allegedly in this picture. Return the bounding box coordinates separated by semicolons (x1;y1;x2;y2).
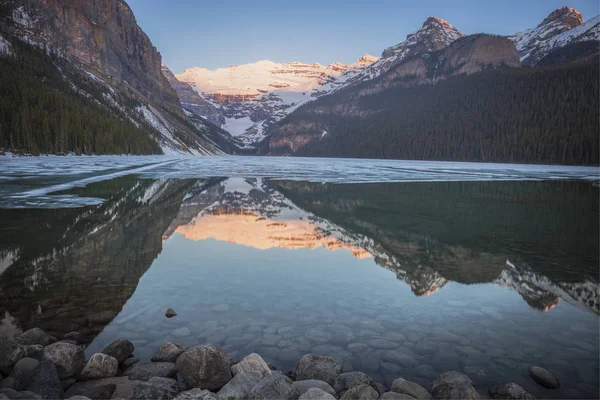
1;0;224;154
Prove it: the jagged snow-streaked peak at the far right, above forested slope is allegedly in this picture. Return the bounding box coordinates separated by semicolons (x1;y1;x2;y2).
508;6;600;65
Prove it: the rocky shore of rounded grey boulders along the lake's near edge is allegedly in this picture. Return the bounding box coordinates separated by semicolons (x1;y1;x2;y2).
0;328;560;400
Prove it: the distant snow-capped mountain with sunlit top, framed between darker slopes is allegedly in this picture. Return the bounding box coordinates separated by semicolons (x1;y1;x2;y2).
174;54;377;147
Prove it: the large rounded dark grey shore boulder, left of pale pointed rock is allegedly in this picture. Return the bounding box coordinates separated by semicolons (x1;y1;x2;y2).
177;345;232;390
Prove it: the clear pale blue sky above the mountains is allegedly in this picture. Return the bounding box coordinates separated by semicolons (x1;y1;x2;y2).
126;0;600;73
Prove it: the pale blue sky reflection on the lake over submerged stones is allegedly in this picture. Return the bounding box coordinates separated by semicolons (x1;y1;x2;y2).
87;233;598;397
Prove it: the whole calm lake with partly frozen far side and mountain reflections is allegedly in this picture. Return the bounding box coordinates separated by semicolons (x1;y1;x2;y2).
0;157;600;398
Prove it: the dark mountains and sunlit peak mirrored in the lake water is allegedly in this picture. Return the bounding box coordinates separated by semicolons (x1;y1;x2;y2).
0;176;599;395
